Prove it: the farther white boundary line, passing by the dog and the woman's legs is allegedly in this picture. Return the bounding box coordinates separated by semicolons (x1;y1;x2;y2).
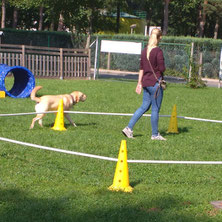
0;111;222;123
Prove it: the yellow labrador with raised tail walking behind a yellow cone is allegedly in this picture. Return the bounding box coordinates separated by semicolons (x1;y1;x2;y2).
30;86;86;129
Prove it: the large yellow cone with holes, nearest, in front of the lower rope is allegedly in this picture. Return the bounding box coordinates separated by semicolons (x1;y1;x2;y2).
108;140;133;192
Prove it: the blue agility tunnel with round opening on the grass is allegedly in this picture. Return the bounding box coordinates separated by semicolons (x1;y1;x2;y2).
0;64;35;98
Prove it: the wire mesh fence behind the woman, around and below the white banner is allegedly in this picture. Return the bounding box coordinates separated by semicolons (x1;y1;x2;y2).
91;39;221;79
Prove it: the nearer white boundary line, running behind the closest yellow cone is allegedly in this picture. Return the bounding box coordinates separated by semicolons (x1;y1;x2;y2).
0;137;222;165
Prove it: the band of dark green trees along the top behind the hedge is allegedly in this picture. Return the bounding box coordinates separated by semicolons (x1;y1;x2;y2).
1;0;222;38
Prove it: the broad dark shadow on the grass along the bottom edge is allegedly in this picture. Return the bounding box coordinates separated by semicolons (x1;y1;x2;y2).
0;189;219;222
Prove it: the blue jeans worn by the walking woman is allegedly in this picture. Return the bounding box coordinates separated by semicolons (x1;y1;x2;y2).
128;83;163;136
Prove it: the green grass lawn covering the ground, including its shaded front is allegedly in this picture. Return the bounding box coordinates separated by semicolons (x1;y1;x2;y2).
0;79;222;222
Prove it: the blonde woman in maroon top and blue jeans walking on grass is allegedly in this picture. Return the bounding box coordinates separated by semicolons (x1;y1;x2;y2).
122;28;166;140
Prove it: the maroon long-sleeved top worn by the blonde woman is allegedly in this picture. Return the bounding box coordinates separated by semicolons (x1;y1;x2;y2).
140;47;166;87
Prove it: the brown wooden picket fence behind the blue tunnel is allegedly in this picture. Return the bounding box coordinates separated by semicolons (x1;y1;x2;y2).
0;44;90;79
